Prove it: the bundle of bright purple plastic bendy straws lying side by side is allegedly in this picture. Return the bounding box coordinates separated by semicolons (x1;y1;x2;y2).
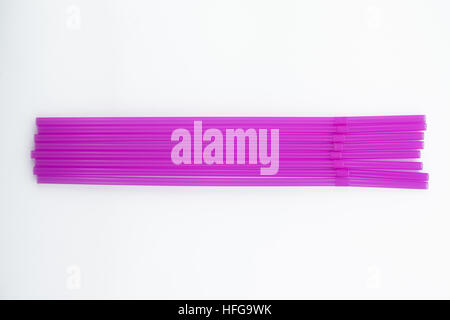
32;115;428;189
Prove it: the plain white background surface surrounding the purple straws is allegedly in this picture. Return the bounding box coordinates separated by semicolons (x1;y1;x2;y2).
0;0;450;299
